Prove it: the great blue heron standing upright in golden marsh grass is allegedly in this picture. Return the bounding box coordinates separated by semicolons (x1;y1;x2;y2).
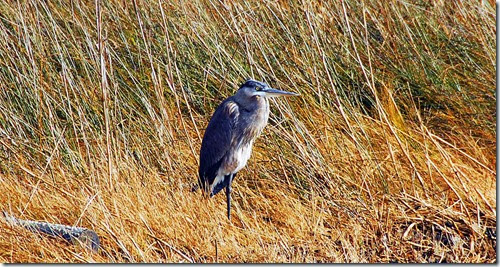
198;79;298;219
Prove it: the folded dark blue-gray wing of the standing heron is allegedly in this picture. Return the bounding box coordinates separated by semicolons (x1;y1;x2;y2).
198;97;240;192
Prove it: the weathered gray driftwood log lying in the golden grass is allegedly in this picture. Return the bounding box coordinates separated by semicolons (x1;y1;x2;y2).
2;211;100;252
